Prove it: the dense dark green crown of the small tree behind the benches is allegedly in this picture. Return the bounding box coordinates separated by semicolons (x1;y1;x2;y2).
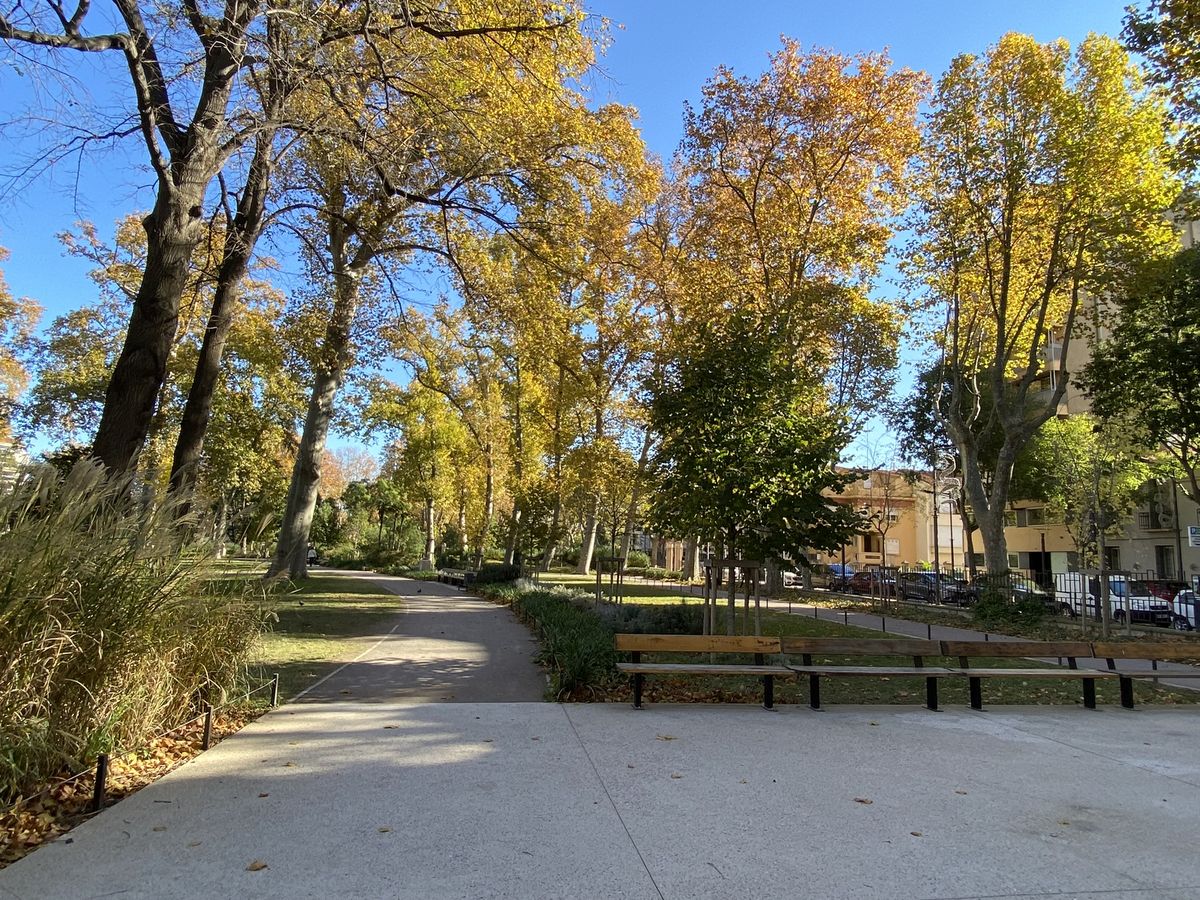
650;313;858;558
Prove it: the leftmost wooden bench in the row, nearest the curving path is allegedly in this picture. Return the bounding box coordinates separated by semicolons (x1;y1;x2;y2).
614;635;792;709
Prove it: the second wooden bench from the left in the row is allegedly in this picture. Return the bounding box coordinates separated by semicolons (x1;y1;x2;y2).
782;637;958;709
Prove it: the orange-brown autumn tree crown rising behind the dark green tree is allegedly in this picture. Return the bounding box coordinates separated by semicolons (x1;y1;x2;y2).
674;40;926;413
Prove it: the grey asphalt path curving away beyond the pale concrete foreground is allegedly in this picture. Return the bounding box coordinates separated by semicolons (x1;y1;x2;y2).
295;569;546;703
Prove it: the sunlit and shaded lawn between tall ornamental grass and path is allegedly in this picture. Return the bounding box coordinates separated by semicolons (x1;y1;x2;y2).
243;575;401;702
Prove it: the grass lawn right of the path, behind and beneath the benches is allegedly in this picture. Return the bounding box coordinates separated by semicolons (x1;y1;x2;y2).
542;575;1200;707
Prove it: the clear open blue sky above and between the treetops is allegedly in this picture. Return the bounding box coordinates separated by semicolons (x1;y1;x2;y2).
0;0;1127;451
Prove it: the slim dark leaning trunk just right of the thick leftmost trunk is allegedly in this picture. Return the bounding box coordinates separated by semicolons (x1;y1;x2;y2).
170;130;274;504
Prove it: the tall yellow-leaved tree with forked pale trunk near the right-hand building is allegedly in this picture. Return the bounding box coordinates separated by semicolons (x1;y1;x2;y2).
908;34;1176;571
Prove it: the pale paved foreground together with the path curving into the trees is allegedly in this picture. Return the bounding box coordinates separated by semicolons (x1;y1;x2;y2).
0;578;1200;900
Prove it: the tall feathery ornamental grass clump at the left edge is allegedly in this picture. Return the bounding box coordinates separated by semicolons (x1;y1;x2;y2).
0;461;265;797
